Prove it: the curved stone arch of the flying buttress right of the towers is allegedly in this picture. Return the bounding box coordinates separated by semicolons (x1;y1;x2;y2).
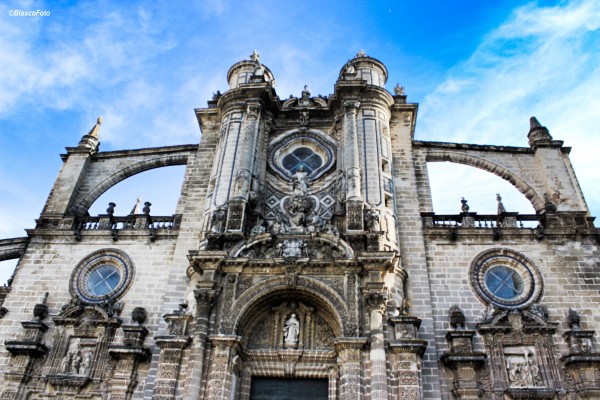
425;150;544;213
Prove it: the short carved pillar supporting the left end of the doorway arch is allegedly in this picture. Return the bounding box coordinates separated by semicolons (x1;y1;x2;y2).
205;335;241;400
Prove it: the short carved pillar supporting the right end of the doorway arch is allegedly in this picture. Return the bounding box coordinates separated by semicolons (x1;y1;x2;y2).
335;337;367;400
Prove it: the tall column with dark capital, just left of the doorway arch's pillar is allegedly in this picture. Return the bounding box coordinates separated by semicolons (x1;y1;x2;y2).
185;282;219;400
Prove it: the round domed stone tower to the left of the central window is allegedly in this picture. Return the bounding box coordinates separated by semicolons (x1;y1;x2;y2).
205;50;275;236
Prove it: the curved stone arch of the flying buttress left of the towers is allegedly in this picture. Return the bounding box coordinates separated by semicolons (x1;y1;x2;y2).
70;154;188;215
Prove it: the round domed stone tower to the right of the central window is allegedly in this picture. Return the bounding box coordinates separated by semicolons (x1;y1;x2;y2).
336;50;397;250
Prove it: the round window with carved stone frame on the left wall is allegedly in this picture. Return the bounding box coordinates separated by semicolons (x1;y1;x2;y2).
70;249;133;303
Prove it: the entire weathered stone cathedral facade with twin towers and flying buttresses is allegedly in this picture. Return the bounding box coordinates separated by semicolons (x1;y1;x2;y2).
0;51;600;400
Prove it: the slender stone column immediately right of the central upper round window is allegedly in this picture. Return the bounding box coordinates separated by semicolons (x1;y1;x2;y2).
344;101;364;232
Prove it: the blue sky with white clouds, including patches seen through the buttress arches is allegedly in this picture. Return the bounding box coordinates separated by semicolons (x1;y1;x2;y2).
0;0;600;280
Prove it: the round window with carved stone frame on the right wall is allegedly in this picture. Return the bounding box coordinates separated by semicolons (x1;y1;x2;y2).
470;249;543;309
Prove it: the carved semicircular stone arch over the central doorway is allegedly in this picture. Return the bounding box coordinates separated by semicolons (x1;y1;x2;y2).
232;277;349;337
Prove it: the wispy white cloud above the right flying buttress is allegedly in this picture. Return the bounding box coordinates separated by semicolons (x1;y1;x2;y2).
417;0;600;215
